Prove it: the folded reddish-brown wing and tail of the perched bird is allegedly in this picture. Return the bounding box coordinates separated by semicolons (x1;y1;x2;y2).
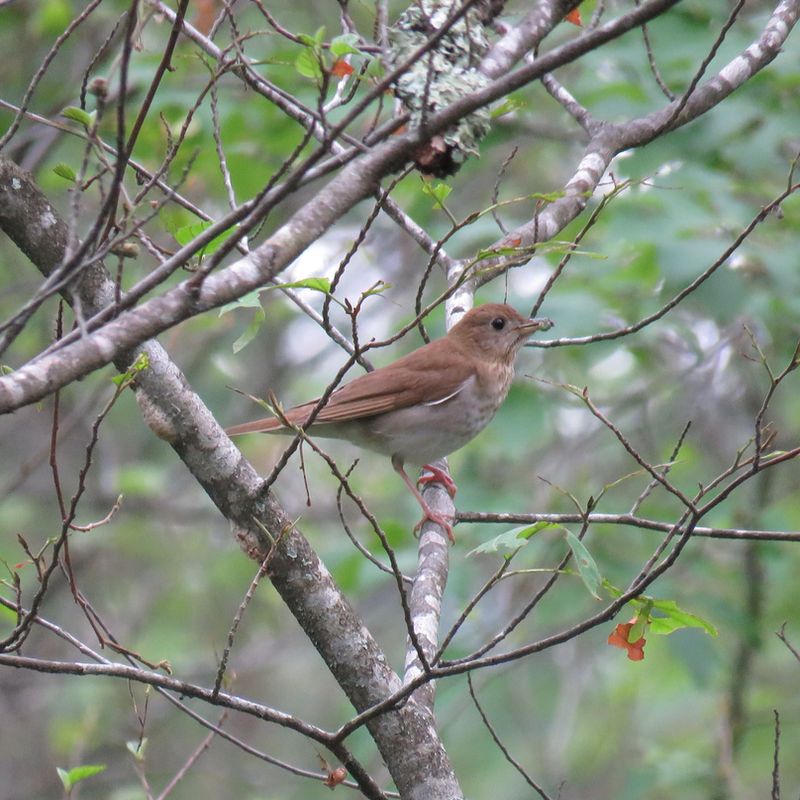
226;339;474;435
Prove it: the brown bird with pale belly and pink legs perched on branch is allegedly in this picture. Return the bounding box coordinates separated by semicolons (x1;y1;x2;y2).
226;303;553;542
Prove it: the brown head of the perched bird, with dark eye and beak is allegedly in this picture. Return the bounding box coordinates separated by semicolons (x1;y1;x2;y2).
448;303;553;362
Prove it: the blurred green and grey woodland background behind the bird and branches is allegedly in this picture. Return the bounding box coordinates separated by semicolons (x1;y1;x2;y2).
0;0;800;800
